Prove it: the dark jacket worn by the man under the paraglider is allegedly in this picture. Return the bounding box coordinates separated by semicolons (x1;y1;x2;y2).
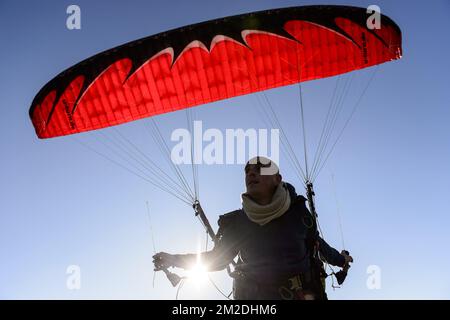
177;184;345;299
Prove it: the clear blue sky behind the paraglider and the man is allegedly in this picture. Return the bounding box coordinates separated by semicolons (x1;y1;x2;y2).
0;0;450;299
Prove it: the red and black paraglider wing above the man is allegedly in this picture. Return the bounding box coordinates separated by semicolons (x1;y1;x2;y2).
29;6;401;138
